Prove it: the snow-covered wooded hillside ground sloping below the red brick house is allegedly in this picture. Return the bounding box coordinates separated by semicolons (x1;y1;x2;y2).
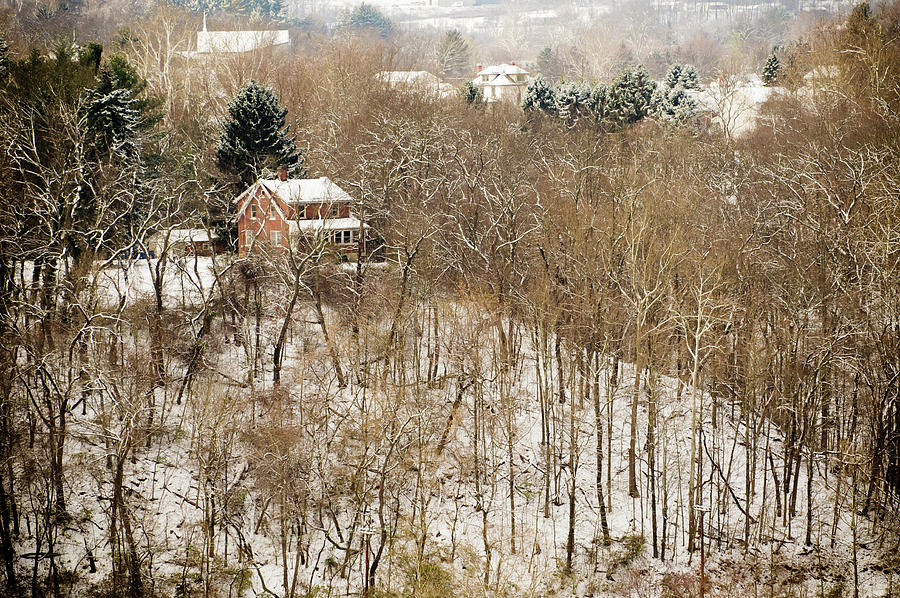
26;259;891;597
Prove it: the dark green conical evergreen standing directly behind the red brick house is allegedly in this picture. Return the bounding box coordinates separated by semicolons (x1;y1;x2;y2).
216;81;304;185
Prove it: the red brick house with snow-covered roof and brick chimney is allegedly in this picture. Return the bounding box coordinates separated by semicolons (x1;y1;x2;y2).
234;170;367;259
